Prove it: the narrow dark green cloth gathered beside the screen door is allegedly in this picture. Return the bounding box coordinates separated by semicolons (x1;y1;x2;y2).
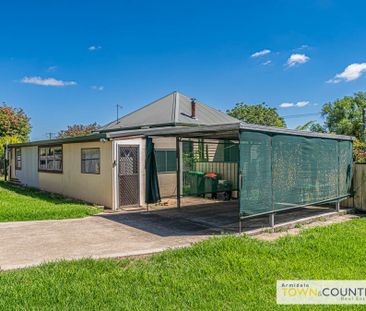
145;137;160;204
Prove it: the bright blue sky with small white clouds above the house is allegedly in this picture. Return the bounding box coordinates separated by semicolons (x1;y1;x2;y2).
0;0;366;139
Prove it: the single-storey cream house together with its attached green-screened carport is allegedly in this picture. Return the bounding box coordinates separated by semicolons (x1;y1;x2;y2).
8;92;354;224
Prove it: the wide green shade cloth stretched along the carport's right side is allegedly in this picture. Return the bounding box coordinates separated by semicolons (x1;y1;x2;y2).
240;131;352;217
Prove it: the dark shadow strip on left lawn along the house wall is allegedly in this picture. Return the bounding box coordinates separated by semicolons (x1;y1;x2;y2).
0;180;93;207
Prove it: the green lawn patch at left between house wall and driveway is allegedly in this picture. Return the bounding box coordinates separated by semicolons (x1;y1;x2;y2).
0;180;101;222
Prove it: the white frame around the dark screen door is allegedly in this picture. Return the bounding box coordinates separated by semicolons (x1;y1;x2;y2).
112;138;145;210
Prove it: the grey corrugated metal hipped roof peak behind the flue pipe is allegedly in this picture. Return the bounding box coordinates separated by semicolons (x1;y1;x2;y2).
99;92;240;132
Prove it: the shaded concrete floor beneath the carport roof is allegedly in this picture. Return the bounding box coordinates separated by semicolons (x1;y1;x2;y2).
114;197;346;235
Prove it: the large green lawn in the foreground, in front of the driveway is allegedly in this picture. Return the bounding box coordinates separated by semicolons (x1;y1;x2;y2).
0;218;366;310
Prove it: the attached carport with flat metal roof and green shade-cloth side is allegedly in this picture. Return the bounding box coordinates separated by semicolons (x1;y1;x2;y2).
110;123;353;231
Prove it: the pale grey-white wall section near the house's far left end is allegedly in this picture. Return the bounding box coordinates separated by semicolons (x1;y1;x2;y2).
13;146;39;188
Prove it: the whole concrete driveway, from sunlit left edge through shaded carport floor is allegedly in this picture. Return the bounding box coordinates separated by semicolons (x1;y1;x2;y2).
0;202;337;270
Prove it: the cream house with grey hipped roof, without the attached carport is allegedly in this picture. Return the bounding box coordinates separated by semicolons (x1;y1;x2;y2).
9;92;240;209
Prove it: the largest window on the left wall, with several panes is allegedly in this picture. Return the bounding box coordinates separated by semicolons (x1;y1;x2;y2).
38;146;62;173
